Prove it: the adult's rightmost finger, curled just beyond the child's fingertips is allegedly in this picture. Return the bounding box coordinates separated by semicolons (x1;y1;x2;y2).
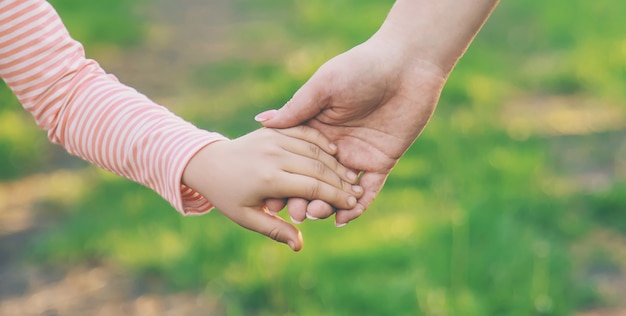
335;172;388;227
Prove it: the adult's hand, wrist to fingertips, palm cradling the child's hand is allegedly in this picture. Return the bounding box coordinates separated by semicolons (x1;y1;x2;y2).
256;36;446;226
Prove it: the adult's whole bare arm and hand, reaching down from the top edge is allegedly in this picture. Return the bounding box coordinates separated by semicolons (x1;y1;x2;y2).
256;0;497;226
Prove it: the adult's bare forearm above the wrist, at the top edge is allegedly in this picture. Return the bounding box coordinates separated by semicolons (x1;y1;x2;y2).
375;0;498;75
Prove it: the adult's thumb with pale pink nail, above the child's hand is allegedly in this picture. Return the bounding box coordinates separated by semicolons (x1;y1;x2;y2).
254;76;327;128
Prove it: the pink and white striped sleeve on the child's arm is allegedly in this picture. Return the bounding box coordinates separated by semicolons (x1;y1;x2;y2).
0;0;225;214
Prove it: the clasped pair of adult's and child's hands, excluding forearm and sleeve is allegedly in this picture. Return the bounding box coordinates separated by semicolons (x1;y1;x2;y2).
183;36;446;251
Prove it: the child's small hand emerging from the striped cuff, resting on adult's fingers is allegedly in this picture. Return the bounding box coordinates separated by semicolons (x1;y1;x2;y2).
183;126;363;251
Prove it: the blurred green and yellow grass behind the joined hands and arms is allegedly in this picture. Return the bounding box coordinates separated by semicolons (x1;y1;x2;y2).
0;0;626;315
